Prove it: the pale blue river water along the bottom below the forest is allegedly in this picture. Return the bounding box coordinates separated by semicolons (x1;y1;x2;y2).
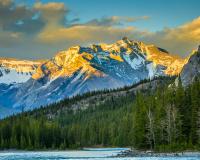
0;148;200;160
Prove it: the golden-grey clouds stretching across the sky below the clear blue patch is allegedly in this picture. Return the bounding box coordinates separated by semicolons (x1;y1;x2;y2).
0;0;200;58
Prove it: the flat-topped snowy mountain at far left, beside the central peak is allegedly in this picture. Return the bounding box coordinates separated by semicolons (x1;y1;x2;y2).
0;58;44;118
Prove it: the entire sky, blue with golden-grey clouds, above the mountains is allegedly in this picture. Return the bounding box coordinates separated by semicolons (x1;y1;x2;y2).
0;0;200;59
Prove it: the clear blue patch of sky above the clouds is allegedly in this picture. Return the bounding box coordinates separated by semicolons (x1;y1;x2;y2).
23;0;200;31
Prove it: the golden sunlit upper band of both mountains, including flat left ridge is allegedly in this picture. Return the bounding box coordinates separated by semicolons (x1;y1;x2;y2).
0;38;188;84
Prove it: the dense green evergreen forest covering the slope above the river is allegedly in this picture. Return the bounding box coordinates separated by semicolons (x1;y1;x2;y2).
0;77;200;151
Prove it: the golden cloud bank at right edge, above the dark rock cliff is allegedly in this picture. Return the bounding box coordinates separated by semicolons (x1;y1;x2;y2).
143;17;200;55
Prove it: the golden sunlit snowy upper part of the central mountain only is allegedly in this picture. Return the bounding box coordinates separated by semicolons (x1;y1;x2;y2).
32;37;186;83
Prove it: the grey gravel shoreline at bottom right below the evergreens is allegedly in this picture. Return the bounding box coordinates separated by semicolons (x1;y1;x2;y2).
115;149;200;157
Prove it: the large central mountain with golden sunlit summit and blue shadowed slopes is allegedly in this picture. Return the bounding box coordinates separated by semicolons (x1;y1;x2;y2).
0;37;187;117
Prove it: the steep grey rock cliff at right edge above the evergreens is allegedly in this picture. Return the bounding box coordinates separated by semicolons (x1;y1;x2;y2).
180;46;200;86
